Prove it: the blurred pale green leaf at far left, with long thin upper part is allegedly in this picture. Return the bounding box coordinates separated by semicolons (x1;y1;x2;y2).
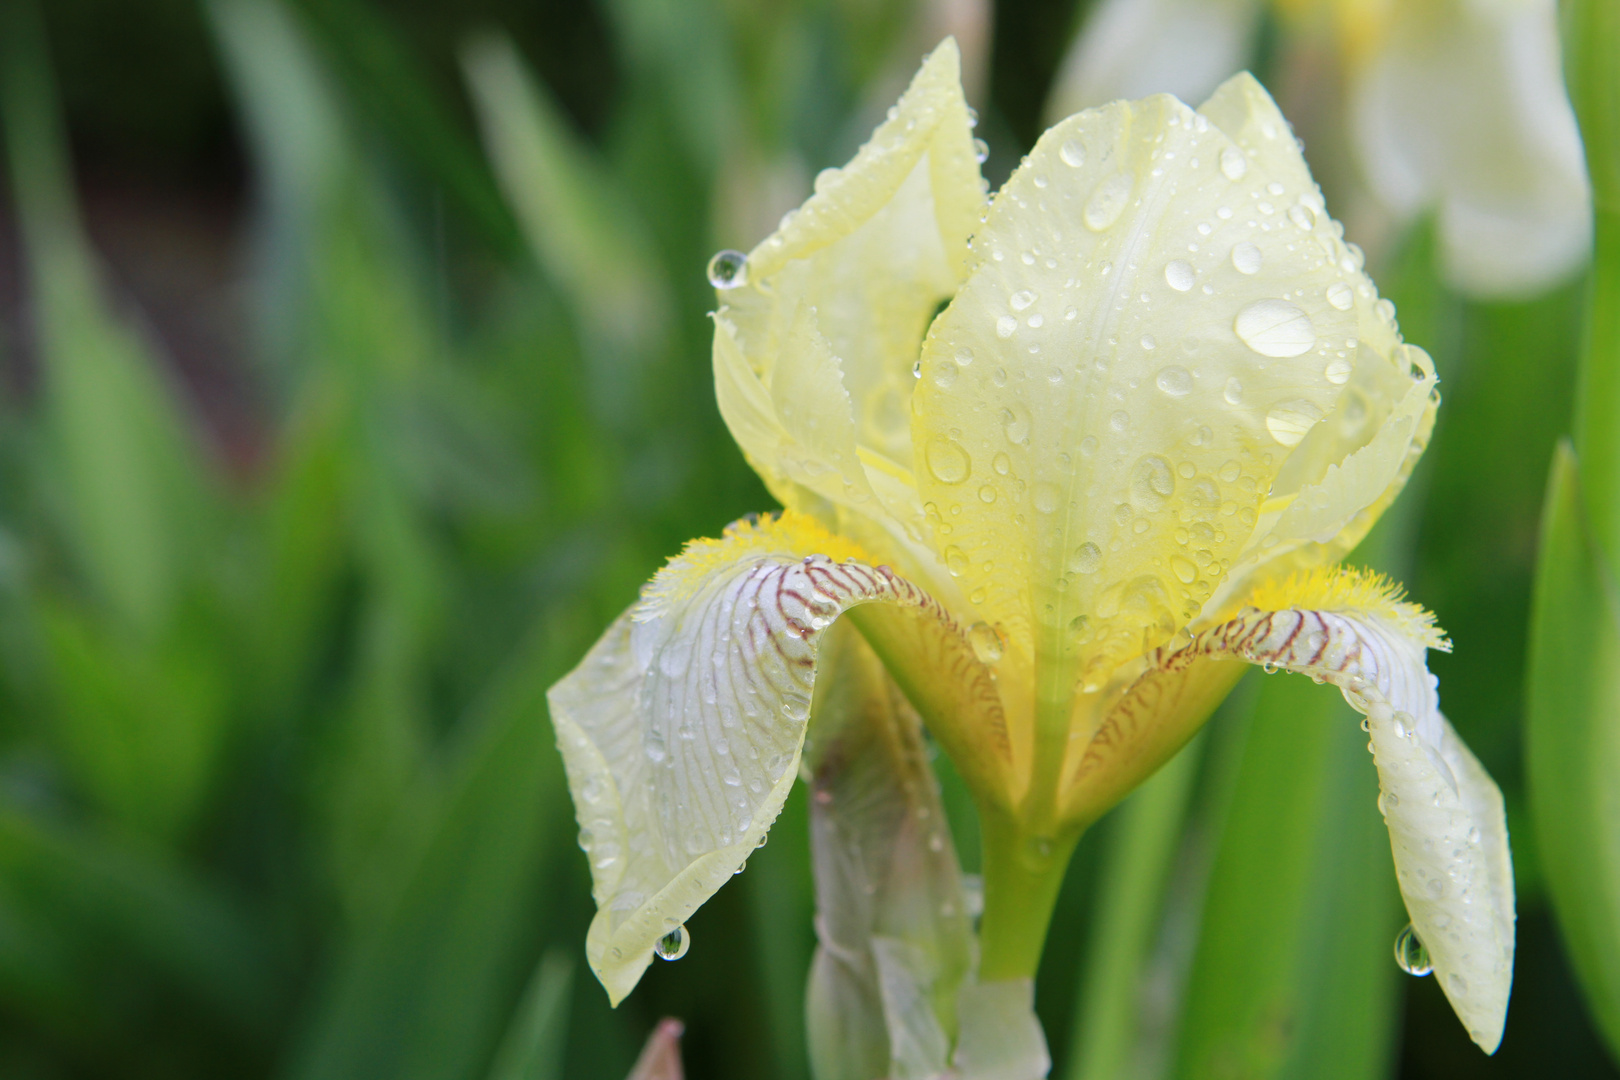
0;3;212;636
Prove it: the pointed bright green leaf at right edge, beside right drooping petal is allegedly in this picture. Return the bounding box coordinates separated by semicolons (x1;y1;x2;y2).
1524;444;1620;1057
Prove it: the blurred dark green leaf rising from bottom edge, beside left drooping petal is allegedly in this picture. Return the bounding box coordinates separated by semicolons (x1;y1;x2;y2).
288;615;567;1080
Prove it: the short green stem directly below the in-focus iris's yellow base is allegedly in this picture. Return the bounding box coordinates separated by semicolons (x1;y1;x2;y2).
978;806;1082;983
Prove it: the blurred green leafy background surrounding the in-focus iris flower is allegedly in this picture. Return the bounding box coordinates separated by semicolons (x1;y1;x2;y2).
0;0;1620;1080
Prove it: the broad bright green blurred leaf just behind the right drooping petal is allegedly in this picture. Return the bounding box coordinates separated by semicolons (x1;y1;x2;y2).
1175;675;1400;1080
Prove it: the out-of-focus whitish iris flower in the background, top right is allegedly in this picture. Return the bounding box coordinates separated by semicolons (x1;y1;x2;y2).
1048;0;1591;298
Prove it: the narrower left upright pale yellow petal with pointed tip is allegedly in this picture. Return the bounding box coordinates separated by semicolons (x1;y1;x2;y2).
714;40;985;592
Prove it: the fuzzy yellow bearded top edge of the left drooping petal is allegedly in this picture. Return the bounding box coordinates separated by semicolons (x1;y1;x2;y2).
632;510;876;622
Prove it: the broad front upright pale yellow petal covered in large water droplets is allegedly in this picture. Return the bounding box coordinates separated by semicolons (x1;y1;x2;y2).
912;74;1395;690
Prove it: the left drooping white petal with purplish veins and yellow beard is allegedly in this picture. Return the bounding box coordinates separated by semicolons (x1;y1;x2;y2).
548;512;995;1004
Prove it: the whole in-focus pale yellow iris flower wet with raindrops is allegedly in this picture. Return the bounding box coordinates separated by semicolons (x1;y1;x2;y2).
551;40;1513;1049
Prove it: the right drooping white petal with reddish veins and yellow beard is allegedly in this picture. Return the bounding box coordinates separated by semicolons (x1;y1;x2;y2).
1114;570;1515;1052
